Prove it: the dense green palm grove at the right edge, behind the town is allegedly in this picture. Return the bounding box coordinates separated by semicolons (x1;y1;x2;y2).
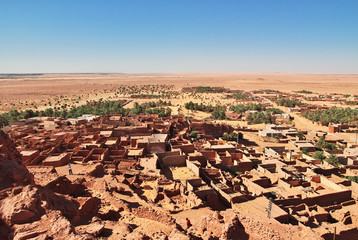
302;108;358;126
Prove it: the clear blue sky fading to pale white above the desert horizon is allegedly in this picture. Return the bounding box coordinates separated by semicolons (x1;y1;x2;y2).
0;0;358;73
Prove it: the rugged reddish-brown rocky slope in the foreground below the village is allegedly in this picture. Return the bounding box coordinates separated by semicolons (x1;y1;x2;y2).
0;132;320;240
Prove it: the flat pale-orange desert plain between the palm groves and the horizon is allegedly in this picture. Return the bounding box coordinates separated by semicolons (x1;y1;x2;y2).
0;73;358;111
